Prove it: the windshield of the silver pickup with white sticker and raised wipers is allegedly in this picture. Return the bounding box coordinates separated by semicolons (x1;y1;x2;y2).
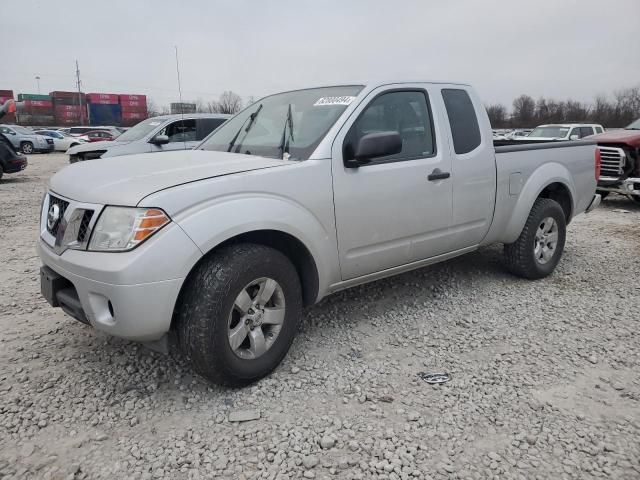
196;85;363;160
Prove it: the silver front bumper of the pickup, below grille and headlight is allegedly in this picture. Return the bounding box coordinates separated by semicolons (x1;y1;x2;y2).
38;221;201;342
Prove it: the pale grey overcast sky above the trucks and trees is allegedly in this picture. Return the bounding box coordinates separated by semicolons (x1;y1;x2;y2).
0;0;640;105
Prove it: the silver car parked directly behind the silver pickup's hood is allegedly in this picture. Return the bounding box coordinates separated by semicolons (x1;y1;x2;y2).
67;113;231;163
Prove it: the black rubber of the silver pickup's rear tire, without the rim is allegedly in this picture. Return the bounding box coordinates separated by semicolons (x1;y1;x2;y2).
504;198;567;280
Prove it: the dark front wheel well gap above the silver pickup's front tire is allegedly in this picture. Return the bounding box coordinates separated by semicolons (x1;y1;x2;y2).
171;230;319;328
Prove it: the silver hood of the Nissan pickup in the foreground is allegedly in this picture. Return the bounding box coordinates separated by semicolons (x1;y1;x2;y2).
49;150;293;206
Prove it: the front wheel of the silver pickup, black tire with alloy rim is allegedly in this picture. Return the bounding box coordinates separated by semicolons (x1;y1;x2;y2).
176;243;302;386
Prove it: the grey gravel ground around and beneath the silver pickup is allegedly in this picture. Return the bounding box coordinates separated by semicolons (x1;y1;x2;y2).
0;155;640;479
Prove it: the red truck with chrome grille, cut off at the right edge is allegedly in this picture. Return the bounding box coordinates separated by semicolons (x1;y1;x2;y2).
589;119;640;204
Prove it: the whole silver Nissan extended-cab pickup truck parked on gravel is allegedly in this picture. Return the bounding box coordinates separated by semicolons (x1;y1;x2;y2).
39;82;600;385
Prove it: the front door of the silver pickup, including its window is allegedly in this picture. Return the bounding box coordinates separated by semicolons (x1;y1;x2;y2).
332;84;451;280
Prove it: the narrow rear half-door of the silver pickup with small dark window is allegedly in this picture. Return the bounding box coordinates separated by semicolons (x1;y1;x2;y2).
441;87;496;250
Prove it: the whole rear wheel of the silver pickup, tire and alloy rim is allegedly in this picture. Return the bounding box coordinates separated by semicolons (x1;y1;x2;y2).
504;198;567;280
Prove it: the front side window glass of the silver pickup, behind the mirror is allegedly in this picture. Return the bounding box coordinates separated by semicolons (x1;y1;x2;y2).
343;91;435;164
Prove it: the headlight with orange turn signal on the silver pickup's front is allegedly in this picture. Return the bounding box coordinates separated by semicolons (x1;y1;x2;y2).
89;207;171;252
